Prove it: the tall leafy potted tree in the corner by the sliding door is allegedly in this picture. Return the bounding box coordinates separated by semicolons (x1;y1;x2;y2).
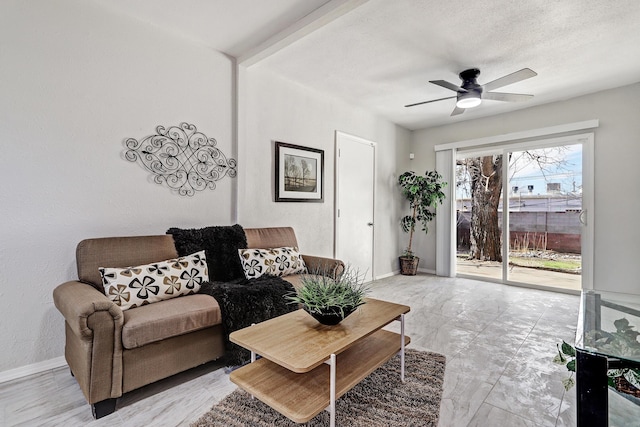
398;171;447;275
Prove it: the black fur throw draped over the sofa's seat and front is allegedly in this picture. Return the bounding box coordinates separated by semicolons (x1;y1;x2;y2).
199;276;298;366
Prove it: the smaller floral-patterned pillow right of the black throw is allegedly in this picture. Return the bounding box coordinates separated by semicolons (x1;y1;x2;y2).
238;247;307;279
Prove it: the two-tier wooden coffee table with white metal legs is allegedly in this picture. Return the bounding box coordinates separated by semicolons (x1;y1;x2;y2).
229;298;411;427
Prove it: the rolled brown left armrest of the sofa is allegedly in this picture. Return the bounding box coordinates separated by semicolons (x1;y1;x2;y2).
53;281;124;339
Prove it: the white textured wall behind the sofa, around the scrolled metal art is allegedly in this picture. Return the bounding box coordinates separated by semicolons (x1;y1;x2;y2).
0;0;235;372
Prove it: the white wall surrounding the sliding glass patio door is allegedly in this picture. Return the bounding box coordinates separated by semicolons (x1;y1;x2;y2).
413;83;640;293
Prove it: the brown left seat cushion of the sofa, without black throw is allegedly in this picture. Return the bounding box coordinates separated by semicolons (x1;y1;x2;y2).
122;294;222;349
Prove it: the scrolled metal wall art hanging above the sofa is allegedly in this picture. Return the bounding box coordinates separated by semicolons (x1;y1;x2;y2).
124;122;238;196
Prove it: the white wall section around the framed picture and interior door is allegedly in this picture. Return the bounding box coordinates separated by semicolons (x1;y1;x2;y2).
238;66;411;276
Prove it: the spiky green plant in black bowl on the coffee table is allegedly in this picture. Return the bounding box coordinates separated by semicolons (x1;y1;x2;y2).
286;266;369;325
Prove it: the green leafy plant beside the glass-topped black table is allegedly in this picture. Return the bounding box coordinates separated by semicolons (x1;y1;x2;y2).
553;318;640;398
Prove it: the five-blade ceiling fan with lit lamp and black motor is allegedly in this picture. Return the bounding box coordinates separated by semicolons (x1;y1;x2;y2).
405;68;538;116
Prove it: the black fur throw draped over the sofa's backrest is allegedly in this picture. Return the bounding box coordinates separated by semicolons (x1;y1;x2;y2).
167;224;247;282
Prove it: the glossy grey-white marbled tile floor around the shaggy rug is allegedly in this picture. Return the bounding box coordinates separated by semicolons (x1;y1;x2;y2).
0;275;638;427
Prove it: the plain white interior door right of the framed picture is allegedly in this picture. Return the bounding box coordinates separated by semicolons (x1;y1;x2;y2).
335;132;376;282
